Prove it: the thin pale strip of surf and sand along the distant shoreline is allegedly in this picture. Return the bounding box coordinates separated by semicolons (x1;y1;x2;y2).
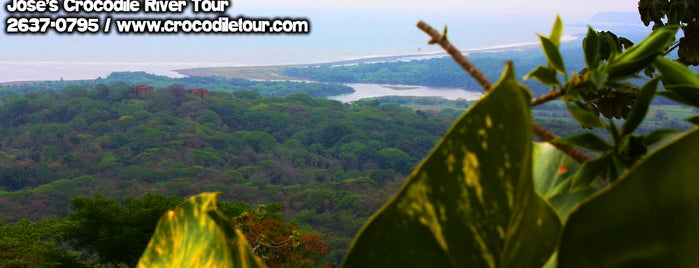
0;36;579;86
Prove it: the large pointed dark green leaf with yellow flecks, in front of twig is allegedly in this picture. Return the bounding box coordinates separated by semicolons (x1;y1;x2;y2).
343;64;560;267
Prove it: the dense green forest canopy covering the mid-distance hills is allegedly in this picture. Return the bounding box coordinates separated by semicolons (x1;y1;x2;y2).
0;78;449;262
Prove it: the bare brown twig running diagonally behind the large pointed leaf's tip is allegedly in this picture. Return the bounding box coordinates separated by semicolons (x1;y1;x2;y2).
417;21;590;163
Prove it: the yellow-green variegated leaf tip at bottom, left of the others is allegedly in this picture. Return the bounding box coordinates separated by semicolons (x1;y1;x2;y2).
138;193;266;267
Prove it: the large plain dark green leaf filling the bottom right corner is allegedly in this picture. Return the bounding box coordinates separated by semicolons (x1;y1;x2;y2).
558;128;699;267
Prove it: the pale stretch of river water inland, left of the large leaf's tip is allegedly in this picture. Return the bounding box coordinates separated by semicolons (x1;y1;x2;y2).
328;83;483;102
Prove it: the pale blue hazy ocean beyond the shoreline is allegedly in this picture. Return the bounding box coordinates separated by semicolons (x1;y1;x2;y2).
0;7;648;82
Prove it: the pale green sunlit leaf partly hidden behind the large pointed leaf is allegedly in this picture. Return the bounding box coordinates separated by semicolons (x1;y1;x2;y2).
532;142;603;220
